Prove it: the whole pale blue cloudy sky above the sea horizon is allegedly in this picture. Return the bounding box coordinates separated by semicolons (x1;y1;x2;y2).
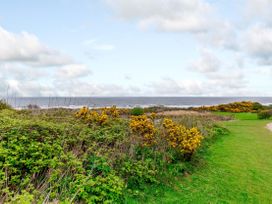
0;0;272;97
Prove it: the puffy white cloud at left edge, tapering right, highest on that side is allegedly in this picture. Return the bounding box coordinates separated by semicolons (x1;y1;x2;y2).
0;27;72;67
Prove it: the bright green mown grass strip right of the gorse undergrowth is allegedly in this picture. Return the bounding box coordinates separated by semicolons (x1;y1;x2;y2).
151;115;272;203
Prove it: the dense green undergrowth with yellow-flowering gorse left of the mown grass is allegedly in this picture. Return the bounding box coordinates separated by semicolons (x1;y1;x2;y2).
0;103;228;203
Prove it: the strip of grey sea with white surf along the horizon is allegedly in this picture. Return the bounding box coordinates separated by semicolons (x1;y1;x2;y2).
3;97;272;108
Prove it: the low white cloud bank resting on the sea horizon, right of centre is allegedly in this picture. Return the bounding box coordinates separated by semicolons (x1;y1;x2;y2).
148;71;250;96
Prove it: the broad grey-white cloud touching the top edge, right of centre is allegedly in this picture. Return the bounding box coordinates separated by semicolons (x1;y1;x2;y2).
106;0;213;32
